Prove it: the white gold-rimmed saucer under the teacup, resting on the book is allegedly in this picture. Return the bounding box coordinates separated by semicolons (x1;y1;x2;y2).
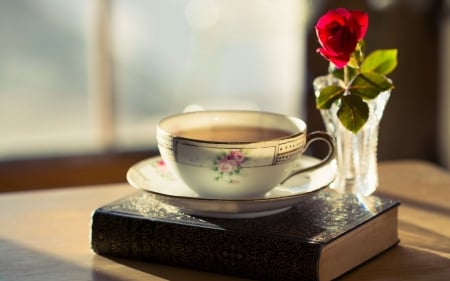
127;156;336;218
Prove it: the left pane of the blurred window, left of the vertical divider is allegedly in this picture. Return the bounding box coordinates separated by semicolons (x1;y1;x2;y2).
0;0;95;158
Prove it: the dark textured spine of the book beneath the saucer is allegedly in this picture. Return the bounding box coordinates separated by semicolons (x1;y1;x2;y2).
91;210;321;280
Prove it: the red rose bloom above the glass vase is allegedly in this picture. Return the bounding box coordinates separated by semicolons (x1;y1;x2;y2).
316;8;369;68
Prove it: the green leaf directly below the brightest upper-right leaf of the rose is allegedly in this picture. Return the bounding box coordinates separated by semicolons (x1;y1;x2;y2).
349;72;393;99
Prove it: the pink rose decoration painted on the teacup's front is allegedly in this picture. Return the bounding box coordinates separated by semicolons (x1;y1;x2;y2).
213;150;249;184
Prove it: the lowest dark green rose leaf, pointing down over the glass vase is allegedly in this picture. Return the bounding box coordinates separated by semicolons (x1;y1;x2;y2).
337;95;369;134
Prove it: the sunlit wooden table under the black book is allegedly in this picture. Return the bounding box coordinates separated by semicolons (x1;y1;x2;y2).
0;161;450;281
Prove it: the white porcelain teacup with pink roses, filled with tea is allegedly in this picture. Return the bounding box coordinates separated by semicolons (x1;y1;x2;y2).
157;110;335;199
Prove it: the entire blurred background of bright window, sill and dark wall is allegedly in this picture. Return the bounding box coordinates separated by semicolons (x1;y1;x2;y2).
0;0;450;191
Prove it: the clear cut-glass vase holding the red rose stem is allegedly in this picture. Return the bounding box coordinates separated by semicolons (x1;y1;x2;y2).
313;75;390;196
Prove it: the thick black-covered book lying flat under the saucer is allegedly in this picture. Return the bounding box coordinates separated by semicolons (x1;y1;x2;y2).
91;188;400;280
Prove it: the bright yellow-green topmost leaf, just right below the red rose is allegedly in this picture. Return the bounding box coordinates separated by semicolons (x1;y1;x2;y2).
361;49;398;75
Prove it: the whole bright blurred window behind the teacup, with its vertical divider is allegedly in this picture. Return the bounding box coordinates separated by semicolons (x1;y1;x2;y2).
0;0;308;159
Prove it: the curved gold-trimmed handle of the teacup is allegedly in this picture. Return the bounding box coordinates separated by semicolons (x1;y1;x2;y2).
281;131;336;184
